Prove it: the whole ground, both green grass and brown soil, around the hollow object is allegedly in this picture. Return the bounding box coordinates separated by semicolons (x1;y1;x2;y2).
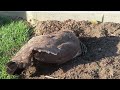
0;17;120;79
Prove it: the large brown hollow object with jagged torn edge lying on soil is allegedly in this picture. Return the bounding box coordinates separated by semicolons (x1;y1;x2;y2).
7;30;86;74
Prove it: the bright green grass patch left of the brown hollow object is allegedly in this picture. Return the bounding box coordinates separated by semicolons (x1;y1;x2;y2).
0;17;32;79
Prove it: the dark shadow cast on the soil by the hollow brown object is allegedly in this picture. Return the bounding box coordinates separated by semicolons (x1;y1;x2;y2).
27;36;120;77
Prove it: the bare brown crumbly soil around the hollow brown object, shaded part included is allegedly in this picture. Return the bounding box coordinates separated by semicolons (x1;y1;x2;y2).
21;19;120;79
